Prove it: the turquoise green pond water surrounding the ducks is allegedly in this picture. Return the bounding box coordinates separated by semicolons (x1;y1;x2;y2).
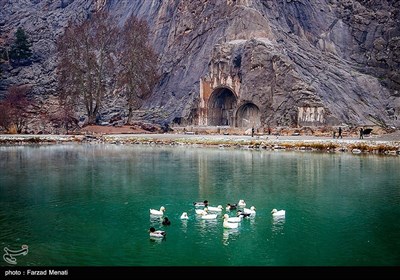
0;144;400;266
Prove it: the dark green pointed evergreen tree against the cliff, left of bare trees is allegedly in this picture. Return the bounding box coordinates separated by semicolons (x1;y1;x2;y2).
10;27;32;64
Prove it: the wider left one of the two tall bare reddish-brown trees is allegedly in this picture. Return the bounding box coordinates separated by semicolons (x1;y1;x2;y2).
58;12;118;124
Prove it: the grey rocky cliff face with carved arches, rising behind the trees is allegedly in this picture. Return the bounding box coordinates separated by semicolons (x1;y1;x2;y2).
0;0;400;127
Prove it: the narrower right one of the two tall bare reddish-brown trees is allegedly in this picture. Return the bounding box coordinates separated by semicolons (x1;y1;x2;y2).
118;16;159;123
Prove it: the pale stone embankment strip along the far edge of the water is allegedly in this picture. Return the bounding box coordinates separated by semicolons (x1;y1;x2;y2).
0;134;400;155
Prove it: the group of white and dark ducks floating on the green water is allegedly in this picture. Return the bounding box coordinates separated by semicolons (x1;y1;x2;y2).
149;199;286;238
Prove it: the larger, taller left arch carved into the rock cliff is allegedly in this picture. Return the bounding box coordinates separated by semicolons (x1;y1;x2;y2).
207;87;237;126
